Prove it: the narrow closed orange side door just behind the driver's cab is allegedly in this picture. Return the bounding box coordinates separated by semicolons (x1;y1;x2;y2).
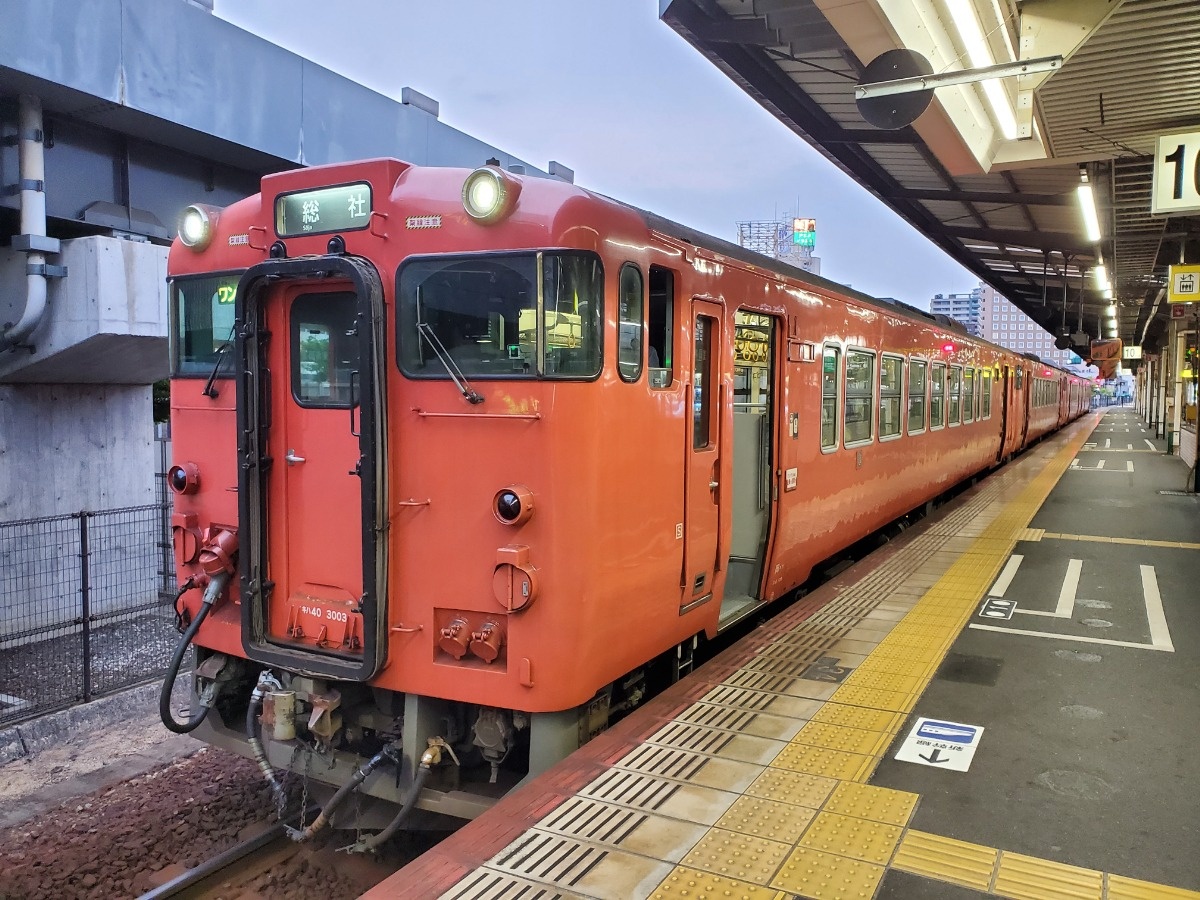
680;300;725;610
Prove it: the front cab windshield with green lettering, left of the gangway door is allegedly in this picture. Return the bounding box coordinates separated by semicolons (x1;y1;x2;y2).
170;272;240;378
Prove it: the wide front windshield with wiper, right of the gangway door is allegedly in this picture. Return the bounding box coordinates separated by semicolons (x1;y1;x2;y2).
396;252;604;378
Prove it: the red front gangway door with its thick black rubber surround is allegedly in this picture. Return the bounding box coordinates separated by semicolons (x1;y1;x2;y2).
239;260;383;679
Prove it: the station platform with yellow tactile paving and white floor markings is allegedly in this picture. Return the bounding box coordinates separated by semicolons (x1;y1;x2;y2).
365;407;1200;900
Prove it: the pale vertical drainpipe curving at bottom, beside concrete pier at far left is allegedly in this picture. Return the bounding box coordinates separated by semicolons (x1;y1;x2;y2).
0;94;46;350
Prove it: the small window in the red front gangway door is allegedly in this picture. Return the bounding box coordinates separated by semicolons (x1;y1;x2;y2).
290;292;359;409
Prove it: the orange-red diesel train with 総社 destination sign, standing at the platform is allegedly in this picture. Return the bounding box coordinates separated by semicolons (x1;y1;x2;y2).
163;160;1090;840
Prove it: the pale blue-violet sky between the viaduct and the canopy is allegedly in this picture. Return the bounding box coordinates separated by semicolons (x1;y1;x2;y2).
215;0;978;308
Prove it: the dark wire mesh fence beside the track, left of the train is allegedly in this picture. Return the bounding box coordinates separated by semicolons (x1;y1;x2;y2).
0;503;179;725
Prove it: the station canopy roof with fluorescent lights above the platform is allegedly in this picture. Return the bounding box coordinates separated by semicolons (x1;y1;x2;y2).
661;0;1200;367
